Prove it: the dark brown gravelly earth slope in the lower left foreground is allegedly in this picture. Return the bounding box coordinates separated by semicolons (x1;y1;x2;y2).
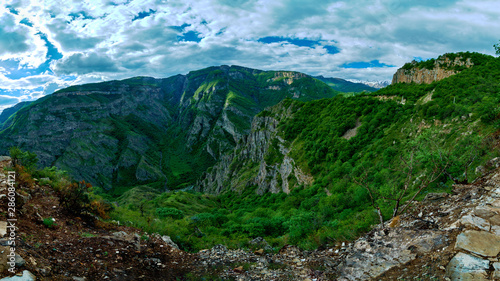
0;161;196;280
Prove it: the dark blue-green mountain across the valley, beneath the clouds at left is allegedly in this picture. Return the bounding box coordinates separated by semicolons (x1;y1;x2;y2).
0;66;338;194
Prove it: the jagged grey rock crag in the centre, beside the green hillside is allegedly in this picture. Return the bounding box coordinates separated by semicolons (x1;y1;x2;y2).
196;100;313;194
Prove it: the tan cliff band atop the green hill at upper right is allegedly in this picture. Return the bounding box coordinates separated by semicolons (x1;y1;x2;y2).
392;57;473;84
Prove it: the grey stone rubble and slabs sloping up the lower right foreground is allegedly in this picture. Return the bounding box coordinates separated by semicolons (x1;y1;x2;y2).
189;165;500;280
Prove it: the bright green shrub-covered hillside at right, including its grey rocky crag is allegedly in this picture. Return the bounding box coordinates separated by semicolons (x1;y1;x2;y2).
111;51;500;250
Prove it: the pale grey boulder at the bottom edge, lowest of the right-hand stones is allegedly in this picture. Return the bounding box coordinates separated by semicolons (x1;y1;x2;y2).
446;253;490;281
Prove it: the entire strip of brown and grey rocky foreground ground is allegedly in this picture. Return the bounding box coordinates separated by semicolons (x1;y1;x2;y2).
0;156;500;281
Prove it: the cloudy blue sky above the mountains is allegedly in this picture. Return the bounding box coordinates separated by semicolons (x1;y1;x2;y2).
0;0;500;110
